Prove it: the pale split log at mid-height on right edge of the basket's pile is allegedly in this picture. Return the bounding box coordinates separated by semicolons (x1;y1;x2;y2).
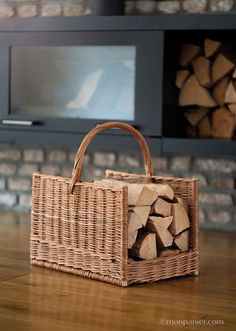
169;203;190;236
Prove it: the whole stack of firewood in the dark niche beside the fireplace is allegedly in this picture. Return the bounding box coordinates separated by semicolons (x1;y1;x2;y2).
175;39;236;139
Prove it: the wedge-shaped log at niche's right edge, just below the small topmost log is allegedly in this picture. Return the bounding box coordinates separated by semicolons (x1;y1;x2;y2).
211;54;235;83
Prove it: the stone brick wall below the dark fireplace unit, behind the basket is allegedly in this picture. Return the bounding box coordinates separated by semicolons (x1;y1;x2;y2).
0;144;236;230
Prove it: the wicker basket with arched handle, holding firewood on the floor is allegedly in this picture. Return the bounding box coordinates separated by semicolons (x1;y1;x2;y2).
31;122;199;286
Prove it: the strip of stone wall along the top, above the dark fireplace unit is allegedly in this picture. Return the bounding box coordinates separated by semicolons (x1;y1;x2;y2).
0;0;236;18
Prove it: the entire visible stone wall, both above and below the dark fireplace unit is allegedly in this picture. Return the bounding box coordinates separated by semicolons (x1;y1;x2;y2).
0;0;236;230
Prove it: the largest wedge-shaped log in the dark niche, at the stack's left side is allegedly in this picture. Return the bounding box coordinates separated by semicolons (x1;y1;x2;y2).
179;75;216;107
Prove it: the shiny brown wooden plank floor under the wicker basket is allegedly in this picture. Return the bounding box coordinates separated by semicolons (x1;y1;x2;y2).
0;212;236;331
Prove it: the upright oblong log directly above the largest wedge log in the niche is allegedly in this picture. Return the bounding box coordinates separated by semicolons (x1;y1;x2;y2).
192;56;212;87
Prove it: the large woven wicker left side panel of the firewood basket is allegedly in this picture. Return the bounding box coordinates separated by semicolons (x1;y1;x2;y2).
31;174;127;281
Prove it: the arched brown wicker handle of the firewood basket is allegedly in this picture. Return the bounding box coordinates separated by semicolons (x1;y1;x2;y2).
69;122;153;193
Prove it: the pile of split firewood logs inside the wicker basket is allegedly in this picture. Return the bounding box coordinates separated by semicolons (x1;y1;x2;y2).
96;179;190;260
